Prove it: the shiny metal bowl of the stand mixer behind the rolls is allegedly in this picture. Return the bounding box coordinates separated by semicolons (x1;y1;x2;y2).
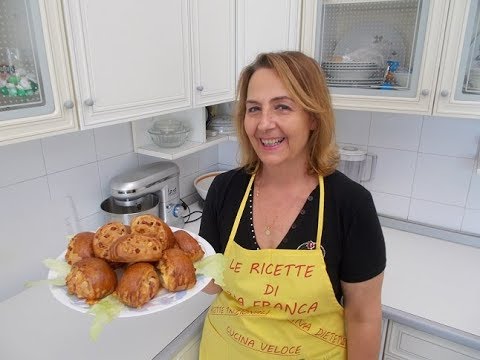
100;193;160;225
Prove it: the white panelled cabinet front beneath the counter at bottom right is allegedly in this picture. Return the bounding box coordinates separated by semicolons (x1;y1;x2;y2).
384;321;480;360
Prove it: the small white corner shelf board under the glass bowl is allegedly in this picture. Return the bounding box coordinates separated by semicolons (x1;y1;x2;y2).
136;135;230;160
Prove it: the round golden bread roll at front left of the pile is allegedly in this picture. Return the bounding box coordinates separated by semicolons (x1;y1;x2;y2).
65;257;117;304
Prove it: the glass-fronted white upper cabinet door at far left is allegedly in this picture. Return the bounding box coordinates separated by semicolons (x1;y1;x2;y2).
0;0;78;145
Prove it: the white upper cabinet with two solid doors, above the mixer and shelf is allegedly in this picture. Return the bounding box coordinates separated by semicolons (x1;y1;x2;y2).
65;0;235;128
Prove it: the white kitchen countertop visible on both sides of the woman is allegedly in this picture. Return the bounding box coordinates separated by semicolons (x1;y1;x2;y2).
0;206;480;360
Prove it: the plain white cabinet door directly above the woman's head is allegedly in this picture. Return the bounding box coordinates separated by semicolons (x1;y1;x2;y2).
237;0;301;75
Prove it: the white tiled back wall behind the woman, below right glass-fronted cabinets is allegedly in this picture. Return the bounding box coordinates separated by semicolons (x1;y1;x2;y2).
219;110;480;235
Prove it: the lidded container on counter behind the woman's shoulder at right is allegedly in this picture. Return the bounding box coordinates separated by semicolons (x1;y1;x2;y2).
337;146;377;183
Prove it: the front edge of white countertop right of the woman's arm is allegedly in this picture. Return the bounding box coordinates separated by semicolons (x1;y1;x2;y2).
382;305;480;351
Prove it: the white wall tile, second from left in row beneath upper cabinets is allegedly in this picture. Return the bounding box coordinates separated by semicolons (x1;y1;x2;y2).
42;130;97;174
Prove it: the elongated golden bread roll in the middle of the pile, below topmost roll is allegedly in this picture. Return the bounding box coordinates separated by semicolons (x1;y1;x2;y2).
108;233;167;263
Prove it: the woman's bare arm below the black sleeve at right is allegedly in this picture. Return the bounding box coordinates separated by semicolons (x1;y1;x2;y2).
341;272;383;360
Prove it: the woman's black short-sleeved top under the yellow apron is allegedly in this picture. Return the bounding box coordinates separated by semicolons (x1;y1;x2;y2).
199;169;386;303
